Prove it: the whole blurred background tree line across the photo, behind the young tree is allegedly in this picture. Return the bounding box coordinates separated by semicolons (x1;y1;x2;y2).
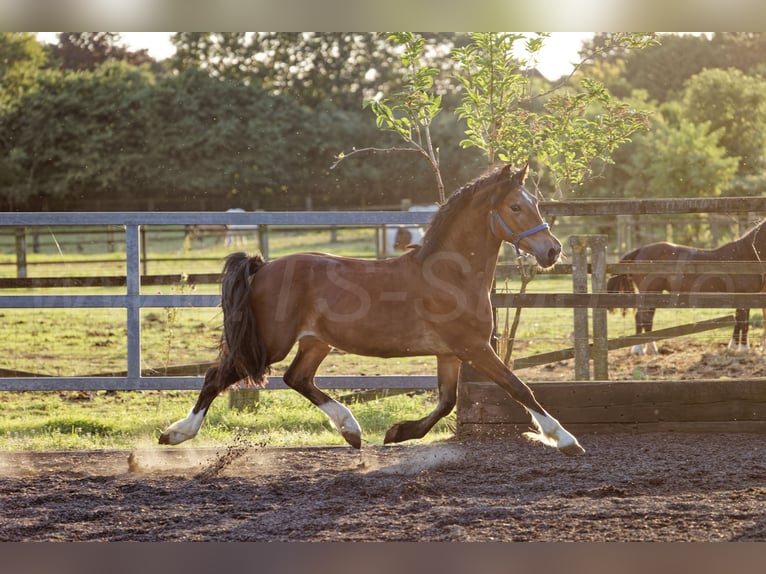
0;33;766;210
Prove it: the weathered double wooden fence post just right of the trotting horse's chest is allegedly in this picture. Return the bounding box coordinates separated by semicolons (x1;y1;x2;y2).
569;235;609;381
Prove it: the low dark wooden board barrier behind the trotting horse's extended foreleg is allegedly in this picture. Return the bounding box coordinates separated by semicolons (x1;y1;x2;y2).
457;380;766;438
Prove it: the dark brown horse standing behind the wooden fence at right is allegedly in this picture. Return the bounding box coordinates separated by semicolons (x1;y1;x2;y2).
606;222;766;354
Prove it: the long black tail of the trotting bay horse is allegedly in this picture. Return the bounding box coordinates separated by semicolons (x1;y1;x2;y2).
219;252;269;385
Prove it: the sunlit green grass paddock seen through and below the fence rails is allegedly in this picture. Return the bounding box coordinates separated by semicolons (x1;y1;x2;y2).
0;229;760;450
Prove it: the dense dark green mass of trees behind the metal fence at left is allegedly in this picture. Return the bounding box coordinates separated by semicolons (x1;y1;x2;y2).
0;61;444;213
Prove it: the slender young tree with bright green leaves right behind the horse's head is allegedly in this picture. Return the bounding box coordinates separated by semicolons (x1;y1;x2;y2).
340;33;654;205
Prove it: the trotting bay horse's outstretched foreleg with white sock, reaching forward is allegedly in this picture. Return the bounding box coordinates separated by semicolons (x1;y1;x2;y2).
463;346;585;455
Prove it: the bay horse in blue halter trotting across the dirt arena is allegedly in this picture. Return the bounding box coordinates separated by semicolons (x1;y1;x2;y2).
159;165;585;455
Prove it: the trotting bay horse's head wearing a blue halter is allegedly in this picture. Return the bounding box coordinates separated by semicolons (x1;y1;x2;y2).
489;163;561;267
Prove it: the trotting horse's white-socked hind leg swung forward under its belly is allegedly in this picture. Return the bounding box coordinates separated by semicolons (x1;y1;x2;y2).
283;336;362;448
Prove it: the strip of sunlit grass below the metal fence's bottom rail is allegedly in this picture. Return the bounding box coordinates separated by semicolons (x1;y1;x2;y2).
0;390;454;450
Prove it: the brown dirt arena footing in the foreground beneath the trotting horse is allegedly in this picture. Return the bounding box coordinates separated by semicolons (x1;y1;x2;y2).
0;434;766;541
